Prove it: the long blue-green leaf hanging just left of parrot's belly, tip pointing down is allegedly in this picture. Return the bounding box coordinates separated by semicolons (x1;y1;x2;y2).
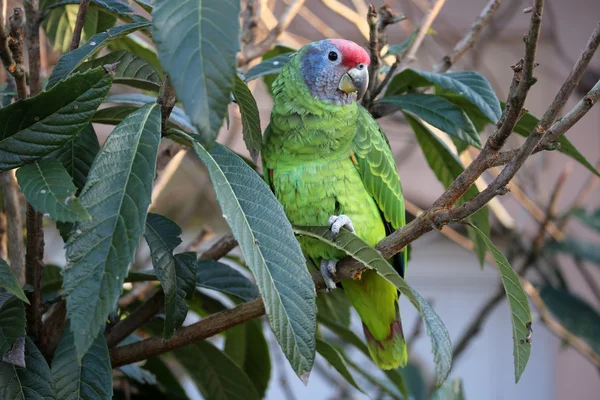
188;142;317;381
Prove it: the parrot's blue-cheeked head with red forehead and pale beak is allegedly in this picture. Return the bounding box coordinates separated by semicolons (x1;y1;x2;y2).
299;39;370;104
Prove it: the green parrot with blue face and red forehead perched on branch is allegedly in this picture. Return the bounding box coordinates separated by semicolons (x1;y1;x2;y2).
262;39;408;369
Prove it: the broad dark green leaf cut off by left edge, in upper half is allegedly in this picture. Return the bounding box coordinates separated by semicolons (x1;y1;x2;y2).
0;68;112;171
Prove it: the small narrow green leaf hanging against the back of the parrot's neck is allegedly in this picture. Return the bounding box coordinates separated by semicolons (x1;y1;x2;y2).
233;75;262;164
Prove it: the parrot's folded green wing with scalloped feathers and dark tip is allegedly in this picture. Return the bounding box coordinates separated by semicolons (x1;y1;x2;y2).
352;106;407;276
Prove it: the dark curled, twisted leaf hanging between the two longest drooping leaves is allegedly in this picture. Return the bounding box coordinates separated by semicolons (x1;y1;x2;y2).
144;213;197;339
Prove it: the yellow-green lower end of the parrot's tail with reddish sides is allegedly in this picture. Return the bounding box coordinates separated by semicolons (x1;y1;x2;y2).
363;306;408;369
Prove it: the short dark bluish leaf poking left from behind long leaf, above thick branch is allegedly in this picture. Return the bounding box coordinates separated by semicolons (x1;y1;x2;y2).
196;260;260;301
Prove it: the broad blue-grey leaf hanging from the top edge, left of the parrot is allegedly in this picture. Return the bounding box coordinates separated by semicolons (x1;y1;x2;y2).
152;0;240;145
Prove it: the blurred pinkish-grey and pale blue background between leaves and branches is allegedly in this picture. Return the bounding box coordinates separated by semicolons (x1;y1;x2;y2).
0;0;600;400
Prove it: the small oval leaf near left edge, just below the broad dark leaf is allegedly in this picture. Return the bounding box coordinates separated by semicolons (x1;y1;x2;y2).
17;158;91;222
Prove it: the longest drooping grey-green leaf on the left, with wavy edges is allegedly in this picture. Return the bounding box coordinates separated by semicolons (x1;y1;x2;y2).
63;104;160;359
